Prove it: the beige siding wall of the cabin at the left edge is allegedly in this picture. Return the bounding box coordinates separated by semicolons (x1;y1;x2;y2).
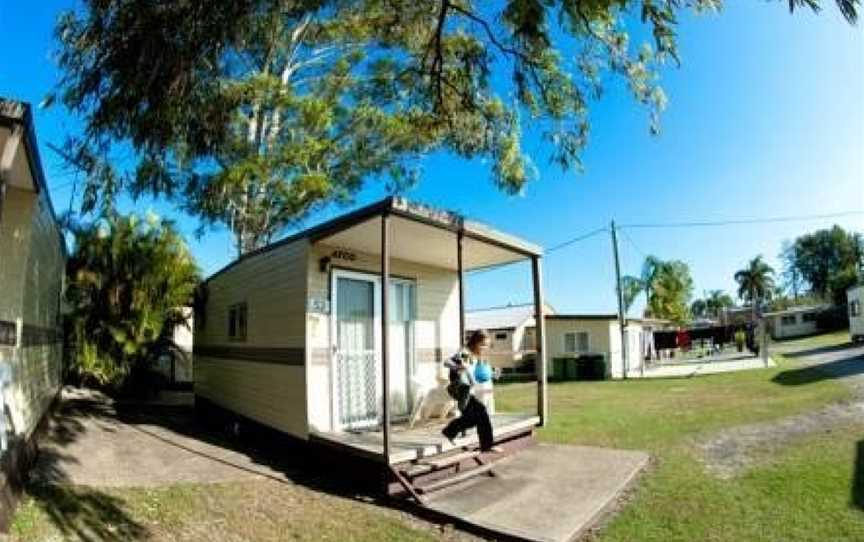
0;185;65;437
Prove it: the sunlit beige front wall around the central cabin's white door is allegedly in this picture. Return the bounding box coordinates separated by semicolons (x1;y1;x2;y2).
307;244;461;431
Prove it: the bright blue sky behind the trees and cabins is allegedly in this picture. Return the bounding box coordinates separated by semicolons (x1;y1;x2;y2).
0;0;864;313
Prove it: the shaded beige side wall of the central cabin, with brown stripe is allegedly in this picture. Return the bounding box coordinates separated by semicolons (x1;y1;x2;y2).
194;239;309;438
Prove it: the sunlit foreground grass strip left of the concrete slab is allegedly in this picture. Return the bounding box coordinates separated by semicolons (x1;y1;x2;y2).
12;480;469;542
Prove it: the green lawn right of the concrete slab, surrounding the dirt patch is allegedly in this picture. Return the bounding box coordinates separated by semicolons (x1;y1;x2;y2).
496;334;864;541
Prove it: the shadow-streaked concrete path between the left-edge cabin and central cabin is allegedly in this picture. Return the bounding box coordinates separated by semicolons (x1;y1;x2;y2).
33;388;286;487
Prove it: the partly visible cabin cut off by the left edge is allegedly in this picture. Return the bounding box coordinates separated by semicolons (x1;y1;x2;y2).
0;98;66;530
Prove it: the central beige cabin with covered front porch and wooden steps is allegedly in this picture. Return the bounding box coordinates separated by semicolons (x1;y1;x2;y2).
193;198;547;501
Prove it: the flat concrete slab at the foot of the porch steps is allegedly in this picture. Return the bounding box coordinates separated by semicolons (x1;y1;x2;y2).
427;444;648;542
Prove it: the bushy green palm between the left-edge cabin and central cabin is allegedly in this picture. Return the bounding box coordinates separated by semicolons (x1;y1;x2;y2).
66;215;199;384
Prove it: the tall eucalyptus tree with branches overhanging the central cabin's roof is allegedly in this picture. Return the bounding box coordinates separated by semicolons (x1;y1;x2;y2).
49;0;859;252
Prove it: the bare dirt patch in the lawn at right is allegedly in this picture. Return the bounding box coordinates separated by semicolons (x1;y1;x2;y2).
697;401;864;479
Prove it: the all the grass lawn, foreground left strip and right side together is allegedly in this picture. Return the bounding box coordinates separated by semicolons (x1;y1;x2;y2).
13;333;864;542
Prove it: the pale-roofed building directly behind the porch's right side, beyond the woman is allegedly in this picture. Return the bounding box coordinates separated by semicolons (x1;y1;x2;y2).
465;303;555;373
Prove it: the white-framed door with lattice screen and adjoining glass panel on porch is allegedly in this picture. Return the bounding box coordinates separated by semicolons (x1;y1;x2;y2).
332;270;415;429
